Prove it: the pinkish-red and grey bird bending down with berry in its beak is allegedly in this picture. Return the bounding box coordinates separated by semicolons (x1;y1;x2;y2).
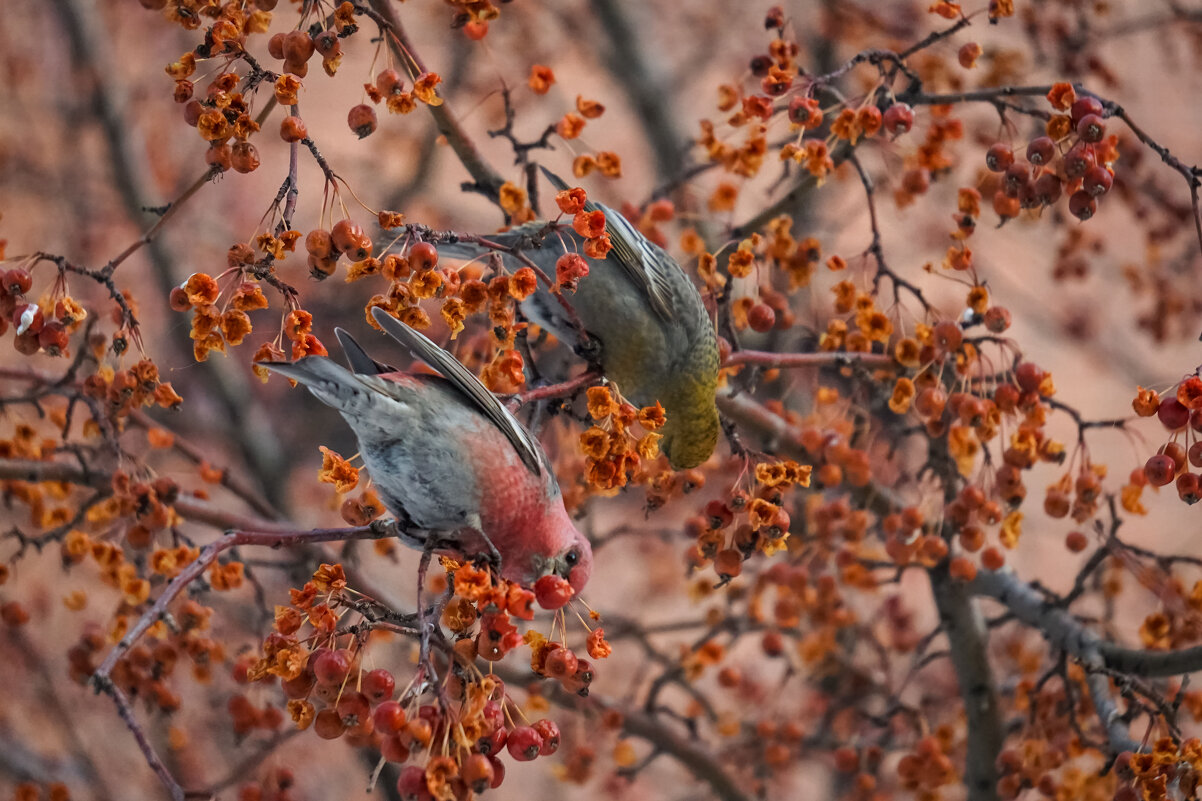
263;309;593;593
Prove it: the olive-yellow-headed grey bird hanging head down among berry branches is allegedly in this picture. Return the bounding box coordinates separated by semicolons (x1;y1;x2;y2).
439;168;720;470
